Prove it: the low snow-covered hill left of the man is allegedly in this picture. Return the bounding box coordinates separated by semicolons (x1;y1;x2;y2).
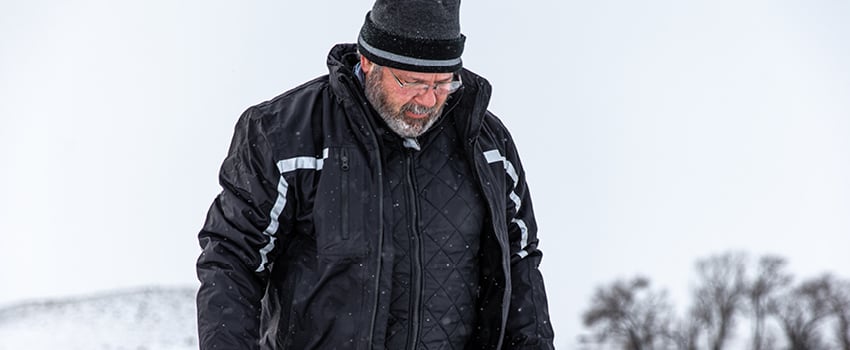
0;288;198;350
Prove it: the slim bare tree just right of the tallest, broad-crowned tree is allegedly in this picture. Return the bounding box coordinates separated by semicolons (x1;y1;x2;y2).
747;255;791;350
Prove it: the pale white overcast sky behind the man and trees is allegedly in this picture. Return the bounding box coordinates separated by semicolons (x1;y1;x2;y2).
0;0;850;348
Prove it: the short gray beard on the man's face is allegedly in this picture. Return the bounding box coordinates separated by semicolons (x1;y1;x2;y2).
366;66;444;138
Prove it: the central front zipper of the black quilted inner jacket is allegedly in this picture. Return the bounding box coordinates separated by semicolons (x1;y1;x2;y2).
406;150;424;350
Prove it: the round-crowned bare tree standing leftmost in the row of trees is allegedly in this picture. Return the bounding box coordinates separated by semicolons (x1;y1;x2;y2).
583;277;671;350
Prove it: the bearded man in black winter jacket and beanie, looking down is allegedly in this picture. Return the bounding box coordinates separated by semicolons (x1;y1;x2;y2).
197;0;553;350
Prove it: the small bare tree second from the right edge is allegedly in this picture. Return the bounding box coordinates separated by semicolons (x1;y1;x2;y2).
777;276;831;350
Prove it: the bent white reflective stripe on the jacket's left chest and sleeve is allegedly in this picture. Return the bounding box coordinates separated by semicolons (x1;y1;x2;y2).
256;148;328;272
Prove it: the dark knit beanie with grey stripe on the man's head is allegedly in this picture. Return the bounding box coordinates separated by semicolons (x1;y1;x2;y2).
357;0;466;73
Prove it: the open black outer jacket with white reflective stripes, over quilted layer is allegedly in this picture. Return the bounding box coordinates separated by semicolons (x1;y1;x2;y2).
197;44;553;350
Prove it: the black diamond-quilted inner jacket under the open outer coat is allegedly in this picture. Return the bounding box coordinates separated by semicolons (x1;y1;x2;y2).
376;108;487;350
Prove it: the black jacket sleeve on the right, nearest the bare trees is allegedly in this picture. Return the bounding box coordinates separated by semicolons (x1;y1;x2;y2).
504;132;554;350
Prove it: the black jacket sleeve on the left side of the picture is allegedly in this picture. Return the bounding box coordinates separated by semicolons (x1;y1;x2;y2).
196;109;288;350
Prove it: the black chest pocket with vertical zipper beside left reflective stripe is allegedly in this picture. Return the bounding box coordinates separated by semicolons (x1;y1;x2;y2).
313;146;370;260
